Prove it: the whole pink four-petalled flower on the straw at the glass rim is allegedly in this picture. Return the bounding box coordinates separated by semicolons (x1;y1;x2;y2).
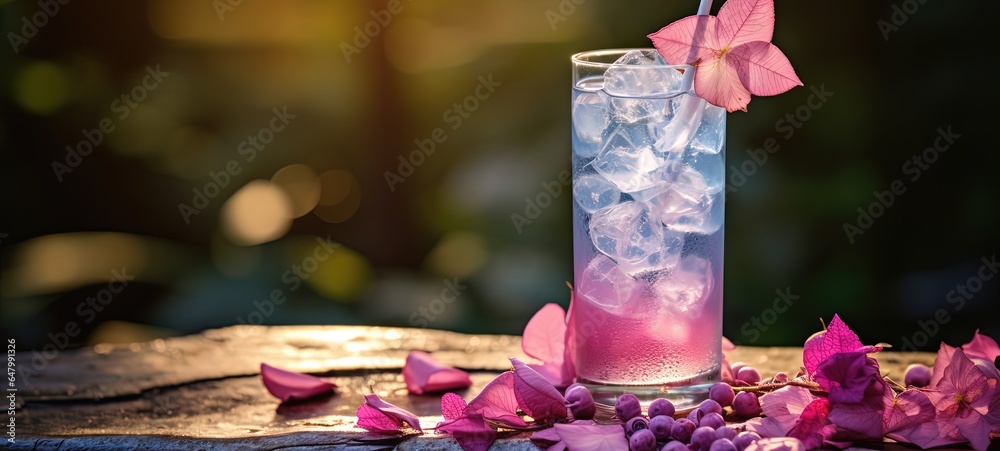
649;0;802;112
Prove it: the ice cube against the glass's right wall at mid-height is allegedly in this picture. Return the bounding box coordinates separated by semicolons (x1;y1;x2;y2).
649;166;725;235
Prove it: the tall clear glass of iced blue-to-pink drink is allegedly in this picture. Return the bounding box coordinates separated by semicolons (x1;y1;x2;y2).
570;49;726;407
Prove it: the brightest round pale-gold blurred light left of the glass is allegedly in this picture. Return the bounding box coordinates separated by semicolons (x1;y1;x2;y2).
220;180;292;246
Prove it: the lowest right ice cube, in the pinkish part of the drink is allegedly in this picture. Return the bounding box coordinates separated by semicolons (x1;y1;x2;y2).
653;255;715;319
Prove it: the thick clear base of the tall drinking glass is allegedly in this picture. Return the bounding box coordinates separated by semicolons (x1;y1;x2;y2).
577;369;720;411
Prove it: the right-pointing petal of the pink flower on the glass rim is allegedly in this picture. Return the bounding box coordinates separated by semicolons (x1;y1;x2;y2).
726;41;802;96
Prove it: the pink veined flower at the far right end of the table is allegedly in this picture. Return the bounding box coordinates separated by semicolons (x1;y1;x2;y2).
927;346;1000;450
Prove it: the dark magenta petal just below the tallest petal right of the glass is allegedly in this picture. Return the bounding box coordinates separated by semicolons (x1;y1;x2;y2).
813;352;882;403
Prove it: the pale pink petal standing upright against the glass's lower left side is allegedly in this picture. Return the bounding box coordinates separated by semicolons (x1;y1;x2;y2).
521;304;576;387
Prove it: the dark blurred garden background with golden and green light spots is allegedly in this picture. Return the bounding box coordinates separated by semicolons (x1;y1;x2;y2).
0;0;1000;350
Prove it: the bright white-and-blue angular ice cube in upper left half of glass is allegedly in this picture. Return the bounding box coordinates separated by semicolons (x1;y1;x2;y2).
591;125;663;193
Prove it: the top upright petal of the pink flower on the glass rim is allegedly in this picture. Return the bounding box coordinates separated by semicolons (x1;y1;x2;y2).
719;0;774;48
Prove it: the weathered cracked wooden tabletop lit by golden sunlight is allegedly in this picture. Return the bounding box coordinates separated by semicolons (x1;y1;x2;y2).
7;326;956;450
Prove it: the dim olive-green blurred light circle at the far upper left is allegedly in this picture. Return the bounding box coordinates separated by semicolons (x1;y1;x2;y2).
13;61;69;115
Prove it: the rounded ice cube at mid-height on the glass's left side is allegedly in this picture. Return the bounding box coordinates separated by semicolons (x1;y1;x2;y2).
590;201;663;264
